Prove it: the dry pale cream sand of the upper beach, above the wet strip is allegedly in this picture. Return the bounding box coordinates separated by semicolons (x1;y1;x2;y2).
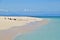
0;16;43;30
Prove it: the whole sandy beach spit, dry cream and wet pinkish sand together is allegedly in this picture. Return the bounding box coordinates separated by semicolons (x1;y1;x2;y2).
0;16;48;40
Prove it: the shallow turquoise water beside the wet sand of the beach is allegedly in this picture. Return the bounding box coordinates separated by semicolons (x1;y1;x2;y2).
15;18;60;40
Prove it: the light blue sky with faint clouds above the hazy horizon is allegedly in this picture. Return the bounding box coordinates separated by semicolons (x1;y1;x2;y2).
0;0;60;13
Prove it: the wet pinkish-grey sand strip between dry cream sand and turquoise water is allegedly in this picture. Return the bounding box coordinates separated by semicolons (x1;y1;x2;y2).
0;16;48;40
